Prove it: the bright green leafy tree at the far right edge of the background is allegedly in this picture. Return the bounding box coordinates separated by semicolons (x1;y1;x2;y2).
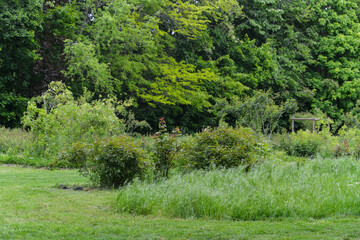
308;0;360;119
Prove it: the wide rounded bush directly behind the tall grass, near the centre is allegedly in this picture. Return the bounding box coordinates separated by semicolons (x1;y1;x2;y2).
179;127;262;169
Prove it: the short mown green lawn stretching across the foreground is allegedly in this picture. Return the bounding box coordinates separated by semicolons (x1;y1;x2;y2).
0;166;360;239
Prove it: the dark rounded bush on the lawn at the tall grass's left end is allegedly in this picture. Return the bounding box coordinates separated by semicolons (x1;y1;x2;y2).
57;136;144;188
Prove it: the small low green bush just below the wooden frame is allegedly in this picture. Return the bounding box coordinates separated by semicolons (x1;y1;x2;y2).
274;130;324;157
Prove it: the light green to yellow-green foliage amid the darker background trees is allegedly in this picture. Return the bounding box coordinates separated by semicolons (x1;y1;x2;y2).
60;1;216;113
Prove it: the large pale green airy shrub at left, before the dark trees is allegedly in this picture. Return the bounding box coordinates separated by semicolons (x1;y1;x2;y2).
23;82;124;158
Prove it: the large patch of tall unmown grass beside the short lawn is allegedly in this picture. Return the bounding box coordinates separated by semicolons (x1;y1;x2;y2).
117;158;360;220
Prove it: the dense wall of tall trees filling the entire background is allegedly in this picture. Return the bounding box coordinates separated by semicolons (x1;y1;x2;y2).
0;0;360;131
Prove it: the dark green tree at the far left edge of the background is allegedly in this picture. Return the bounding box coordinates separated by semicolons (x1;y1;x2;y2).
0;0;43;127
